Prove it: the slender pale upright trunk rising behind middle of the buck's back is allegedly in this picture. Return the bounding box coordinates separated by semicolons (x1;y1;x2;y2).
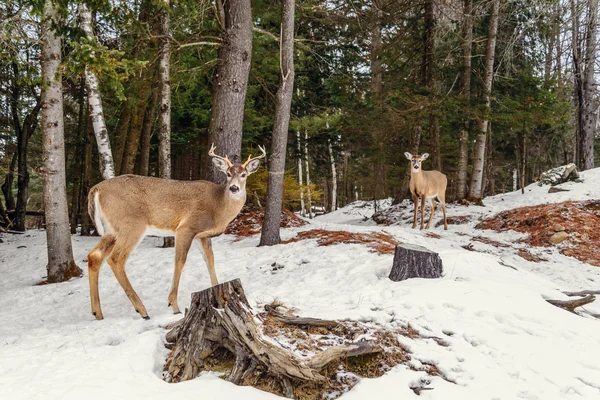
158;0;171;179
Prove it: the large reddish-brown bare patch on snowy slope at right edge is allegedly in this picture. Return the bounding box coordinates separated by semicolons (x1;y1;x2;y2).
476;200;600;266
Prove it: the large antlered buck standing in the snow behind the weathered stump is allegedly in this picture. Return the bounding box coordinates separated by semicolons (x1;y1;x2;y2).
88;145;266;319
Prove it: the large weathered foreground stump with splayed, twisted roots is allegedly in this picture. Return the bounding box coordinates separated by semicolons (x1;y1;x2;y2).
165;279;383;398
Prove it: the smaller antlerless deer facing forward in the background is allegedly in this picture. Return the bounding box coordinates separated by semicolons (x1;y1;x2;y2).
404;152;448;230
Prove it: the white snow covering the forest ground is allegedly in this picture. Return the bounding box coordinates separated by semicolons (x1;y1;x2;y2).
0;169;600;400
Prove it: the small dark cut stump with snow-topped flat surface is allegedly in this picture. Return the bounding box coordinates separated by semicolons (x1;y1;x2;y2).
390;244;442;282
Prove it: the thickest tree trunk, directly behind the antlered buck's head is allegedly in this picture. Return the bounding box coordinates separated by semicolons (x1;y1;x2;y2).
206;0;252;183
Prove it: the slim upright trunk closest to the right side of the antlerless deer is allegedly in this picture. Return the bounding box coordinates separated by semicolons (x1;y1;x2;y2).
456;0;473;200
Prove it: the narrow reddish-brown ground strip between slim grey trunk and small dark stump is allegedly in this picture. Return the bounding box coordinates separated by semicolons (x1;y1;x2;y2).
281;229;400;254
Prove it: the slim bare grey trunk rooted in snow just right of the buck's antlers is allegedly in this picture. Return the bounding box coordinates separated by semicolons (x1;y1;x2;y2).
259;0;295;246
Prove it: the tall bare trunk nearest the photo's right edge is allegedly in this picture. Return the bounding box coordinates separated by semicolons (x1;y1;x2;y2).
581;0;598;170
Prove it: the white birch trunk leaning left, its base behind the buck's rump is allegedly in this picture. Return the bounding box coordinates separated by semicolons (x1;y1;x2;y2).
78;2;115;179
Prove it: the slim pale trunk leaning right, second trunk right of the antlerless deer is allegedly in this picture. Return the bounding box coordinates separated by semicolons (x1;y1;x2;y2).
469;0;500;201
